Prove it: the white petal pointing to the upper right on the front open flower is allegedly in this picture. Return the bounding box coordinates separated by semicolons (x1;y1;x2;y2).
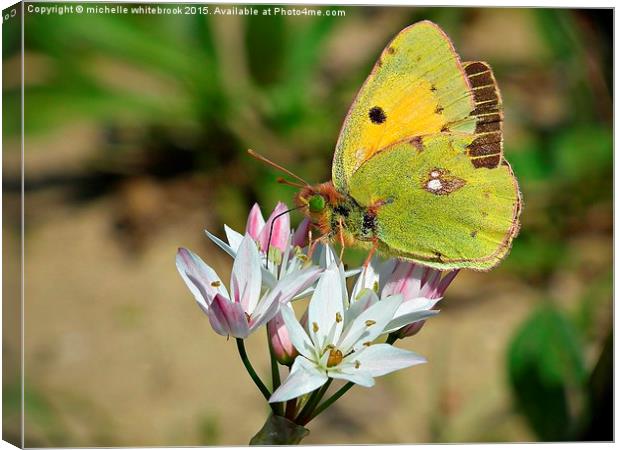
338;295;402;354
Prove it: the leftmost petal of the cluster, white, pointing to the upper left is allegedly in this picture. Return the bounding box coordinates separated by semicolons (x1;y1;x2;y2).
176;248;228;312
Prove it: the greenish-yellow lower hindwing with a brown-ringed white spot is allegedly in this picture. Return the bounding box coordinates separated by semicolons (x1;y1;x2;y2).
350;133;521;270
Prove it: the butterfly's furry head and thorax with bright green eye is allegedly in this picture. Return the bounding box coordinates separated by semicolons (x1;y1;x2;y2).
295;181;376;246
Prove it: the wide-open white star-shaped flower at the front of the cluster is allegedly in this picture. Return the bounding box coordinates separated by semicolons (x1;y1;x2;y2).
269;262;426;402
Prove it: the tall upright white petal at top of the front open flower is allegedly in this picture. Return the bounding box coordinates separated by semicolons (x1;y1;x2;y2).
308;263;344;348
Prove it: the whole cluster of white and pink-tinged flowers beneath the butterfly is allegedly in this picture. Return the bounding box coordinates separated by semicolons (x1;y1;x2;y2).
176;203;457;440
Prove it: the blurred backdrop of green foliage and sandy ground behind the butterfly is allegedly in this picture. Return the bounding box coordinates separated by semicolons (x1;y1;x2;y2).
3;5;613;447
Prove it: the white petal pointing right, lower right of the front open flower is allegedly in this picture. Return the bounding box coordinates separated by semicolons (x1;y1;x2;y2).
343;344;426;377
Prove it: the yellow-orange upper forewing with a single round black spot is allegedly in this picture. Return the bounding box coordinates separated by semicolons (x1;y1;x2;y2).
332;21;478;193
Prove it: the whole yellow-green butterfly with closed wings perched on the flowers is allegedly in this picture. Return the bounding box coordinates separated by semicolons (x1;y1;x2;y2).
249;21;522;271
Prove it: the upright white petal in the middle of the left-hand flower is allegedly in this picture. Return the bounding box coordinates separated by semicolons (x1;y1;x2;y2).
230;235;262;315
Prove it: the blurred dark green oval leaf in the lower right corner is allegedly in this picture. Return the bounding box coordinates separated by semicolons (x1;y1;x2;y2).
508;304;587;441
